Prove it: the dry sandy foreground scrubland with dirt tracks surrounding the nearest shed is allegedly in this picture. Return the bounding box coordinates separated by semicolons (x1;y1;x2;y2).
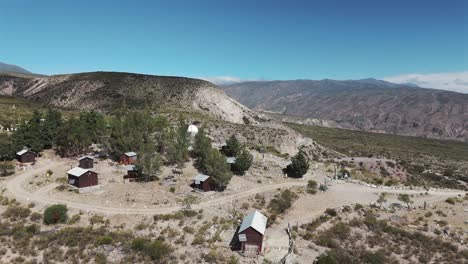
0;148;468;263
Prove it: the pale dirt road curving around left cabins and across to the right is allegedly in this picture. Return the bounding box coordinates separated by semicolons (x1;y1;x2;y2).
6;160;460;215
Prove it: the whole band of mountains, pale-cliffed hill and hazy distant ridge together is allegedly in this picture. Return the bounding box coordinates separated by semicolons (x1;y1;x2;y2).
0;63;468;141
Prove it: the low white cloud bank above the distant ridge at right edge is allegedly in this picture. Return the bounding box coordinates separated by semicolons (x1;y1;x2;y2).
383;71;468;93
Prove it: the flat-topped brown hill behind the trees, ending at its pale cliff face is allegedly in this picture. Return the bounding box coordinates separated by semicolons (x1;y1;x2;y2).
0;72;253;123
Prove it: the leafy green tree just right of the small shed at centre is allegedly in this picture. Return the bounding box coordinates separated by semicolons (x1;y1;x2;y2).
203;149;232;190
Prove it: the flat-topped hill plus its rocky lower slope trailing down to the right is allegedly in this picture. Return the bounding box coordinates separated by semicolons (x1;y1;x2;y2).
0;72;323;155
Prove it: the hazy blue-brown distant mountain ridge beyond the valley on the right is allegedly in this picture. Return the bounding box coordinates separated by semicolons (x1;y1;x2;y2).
223;79;468;141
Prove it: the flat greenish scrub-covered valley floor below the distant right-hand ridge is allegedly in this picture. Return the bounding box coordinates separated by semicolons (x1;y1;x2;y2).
287;123;468;189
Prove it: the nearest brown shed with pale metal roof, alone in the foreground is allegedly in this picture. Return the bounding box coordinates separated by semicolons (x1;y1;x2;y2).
237;210;267;254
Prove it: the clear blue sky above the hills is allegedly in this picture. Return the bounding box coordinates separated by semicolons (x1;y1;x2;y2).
0;0;468;88
